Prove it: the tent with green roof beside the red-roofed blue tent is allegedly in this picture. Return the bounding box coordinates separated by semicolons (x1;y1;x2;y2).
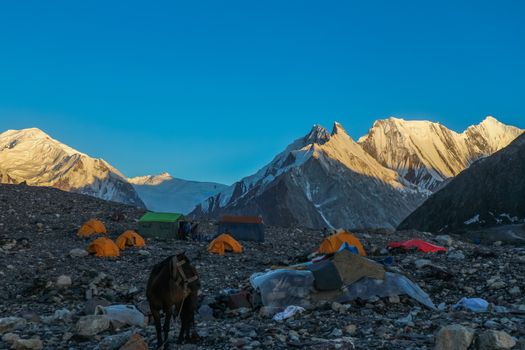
138;212;185;239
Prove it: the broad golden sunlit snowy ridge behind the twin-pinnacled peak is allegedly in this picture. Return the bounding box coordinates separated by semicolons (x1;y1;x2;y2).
359;116;523;190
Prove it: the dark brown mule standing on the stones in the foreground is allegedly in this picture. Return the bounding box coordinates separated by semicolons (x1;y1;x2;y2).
146;253;200;348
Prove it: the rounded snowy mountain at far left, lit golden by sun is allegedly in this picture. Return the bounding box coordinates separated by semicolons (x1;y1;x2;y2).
0;128;144;207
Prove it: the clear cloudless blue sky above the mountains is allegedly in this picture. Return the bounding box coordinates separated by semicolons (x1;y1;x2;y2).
0;0;525;183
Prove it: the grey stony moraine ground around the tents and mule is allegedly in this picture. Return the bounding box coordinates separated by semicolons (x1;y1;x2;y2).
0;185;525;349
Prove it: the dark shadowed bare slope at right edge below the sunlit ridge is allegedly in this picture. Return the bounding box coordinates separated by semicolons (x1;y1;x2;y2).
399;134;525;232
